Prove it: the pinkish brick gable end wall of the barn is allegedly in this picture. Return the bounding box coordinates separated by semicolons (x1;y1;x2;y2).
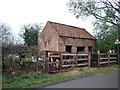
38;23;59;51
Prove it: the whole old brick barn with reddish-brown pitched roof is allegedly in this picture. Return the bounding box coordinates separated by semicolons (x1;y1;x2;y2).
38;21;96;53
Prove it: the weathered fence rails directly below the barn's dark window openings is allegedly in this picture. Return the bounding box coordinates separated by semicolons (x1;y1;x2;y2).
61;53;89;67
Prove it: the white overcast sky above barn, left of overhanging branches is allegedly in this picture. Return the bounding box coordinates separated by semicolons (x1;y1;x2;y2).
0;0;93;35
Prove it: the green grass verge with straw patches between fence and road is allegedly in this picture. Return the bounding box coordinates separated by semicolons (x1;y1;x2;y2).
2;65;118;88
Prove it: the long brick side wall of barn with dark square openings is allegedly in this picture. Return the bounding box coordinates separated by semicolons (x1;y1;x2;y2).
59;37;95;53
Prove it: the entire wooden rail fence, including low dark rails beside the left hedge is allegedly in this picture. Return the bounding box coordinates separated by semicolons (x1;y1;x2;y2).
6;53;117;73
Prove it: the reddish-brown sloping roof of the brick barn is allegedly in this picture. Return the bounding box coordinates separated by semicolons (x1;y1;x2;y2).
49;21;96;39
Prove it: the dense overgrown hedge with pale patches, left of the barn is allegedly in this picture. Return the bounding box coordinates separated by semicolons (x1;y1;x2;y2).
2;46;42;73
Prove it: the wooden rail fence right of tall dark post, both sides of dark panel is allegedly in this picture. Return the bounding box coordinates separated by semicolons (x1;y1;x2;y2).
44;53;117;72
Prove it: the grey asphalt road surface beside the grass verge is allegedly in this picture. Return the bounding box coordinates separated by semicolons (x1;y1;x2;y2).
45;72;118;88
